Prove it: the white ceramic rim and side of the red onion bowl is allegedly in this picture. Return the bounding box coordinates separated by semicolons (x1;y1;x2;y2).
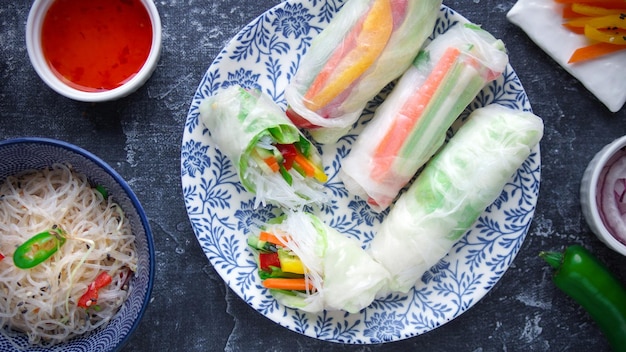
580;136;626;256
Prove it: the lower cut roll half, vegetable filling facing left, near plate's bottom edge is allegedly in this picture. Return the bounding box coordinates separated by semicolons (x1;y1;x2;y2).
248;211;389;313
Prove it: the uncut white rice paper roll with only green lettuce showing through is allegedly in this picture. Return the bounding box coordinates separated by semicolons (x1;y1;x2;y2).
370;105;543;292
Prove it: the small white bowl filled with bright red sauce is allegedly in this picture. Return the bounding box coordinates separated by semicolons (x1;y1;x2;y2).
26;0;162;102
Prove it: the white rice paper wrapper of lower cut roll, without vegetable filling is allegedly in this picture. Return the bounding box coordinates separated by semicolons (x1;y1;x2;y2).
268;212;389;313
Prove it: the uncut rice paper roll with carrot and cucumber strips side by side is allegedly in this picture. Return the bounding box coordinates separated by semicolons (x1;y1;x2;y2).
340;24;508;211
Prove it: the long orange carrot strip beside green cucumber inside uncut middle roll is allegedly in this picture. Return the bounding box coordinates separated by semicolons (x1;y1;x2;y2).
374;47;461;169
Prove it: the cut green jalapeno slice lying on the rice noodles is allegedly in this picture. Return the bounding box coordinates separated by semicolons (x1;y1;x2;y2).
13;225;65;269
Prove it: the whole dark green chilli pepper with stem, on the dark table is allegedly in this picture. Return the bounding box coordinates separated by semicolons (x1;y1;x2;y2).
539;245;626;351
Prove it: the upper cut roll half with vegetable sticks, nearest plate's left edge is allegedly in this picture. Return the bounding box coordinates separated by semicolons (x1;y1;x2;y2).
199;86;327;208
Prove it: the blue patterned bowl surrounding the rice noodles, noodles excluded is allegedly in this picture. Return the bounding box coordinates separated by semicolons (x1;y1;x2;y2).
0;138;155;352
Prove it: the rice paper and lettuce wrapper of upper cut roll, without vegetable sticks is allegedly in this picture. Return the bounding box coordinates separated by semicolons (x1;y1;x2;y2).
199;86;326;208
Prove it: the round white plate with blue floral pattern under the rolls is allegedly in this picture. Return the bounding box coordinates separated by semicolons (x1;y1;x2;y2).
181;0;540;344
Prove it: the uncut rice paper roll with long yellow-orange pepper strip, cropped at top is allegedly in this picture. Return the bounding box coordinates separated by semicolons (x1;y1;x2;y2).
285;0;441;143
